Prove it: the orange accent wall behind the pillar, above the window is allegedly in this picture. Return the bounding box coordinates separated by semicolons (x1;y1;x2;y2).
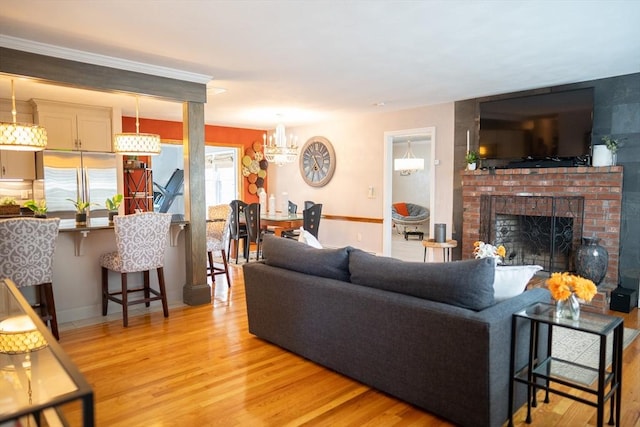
122;116;269;203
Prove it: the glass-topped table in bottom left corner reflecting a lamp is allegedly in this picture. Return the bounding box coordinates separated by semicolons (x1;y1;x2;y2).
0;279;94;427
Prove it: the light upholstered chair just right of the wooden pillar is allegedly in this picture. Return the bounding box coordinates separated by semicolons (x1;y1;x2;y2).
207;204;231;287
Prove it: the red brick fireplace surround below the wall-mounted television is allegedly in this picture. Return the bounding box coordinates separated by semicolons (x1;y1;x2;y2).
462;166;622;287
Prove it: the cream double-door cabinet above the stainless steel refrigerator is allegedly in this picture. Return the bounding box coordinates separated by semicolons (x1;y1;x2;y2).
33;99;113;152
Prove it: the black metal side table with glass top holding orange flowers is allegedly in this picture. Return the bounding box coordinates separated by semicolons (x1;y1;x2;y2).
509;303;624;427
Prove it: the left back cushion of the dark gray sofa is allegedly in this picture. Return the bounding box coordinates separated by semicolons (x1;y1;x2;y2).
262;235;352;282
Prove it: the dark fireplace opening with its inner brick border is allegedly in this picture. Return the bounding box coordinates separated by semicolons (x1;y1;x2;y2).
480;195;584;273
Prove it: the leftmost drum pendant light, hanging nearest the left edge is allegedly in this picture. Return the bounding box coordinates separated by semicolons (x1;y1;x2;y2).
0;80;47;151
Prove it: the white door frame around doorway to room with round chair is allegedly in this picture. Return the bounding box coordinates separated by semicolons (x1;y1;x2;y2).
382;126;437;256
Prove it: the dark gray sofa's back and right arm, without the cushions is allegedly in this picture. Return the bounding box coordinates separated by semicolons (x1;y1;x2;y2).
243;239;548;427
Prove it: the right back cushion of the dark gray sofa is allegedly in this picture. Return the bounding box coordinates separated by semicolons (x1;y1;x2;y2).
349;249;495;311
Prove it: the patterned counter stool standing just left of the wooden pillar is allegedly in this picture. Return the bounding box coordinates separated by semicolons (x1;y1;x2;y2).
100;212;171;327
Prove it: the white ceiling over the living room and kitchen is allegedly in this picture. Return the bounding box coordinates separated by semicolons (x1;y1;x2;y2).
0;0;640;129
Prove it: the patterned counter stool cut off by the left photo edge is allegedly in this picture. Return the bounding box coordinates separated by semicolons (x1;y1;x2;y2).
0;218;60;339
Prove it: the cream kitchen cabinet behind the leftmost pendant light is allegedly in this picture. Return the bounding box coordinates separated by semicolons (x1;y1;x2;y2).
0;100;36;179
